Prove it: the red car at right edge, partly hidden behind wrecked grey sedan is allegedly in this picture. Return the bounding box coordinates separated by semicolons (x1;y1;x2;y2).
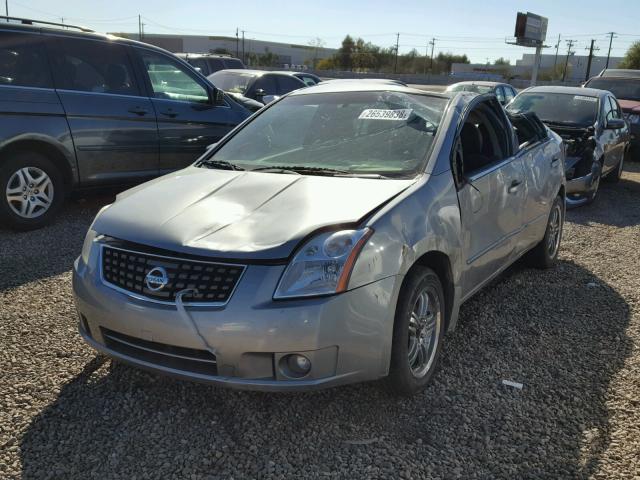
584;69;640;161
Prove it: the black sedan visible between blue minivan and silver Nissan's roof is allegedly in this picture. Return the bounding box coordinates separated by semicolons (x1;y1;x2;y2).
207;69;307;112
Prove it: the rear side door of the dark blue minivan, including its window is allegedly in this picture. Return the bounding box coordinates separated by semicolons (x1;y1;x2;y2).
47;36;158;184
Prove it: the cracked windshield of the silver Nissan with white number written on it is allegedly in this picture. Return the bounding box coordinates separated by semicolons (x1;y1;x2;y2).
208;92;447;176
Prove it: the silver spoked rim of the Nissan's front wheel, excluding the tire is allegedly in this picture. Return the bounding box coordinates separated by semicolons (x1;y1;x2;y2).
408;286;442;378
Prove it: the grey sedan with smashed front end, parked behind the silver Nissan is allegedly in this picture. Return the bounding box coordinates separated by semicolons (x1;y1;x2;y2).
507;87;631;207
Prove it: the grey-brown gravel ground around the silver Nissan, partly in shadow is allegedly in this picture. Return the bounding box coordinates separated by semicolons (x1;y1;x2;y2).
0;164;640;479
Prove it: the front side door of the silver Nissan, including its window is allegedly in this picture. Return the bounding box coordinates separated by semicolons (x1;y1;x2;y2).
458;100;526;296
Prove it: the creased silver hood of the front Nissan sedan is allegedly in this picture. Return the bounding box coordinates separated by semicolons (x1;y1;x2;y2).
93;167;416;260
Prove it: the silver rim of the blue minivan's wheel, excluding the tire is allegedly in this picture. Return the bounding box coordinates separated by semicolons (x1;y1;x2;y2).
5;167;54;218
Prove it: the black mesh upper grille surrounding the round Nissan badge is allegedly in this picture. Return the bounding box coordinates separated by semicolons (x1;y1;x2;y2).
101;245;245;304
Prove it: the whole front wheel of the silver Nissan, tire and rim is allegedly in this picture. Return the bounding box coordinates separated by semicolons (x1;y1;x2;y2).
388;266;446;396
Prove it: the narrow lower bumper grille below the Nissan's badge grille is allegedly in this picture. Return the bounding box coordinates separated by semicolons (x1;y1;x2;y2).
101;328;218;375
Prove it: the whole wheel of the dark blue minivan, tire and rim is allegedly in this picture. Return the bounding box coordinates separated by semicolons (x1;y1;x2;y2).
0;152;65;230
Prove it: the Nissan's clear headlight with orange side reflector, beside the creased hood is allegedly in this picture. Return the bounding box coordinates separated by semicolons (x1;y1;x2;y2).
273;228;373;299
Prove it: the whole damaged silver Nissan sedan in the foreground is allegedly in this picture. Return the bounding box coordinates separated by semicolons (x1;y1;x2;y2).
73;82;565;394
